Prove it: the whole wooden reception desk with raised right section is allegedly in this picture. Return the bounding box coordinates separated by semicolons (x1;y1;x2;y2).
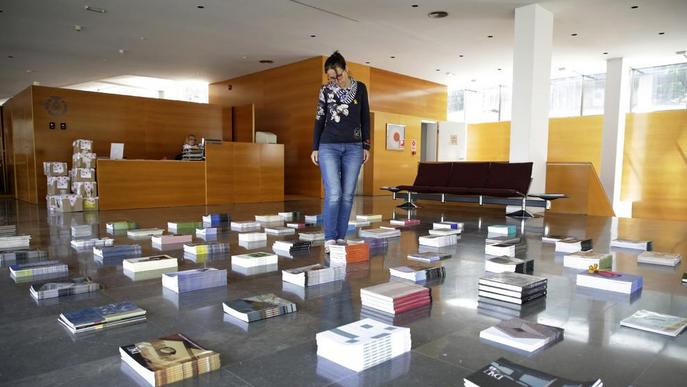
97;142;284;210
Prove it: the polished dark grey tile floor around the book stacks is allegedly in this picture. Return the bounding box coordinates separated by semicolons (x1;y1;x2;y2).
0;197;687;387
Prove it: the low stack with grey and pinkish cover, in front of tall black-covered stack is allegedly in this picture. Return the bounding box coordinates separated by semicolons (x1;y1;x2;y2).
479;318;563;353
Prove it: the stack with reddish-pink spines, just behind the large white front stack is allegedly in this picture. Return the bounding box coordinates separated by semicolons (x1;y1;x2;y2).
360;281;432;314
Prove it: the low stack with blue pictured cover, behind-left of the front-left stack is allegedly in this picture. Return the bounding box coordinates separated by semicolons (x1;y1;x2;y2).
58;301;146;334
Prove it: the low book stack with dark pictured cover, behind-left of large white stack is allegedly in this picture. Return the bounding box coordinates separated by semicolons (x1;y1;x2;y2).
223;293;297;323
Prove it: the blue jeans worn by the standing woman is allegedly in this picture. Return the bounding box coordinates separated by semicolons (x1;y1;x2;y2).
319;143;363;241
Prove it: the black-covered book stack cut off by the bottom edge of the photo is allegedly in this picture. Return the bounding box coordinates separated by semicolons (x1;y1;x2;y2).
463;358;603;387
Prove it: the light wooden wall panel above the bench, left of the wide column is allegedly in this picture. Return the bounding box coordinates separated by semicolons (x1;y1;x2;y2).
466;121;510;161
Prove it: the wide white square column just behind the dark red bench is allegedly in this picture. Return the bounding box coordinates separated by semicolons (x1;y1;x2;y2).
509;4;553;192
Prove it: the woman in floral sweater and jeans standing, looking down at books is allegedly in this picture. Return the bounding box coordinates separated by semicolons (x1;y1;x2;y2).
310;51;370;252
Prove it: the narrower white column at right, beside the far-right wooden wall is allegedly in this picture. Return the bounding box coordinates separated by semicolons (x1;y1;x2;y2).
599;58;632;216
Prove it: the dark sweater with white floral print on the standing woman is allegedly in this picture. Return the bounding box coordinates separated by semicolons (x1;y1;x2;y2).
312;79;370;150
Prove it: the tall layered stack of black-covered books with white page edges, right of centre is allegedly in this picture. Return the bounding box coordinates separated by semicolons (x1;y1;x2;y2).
478;273;547;304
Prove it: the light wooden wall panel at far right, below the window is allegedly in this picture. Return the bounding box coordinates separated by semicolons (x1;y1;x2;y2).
621;110;687;220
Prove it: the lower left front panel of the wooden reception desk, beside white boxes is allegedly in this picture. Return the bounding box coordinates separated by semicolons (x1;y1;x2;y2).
97;160;205;210
